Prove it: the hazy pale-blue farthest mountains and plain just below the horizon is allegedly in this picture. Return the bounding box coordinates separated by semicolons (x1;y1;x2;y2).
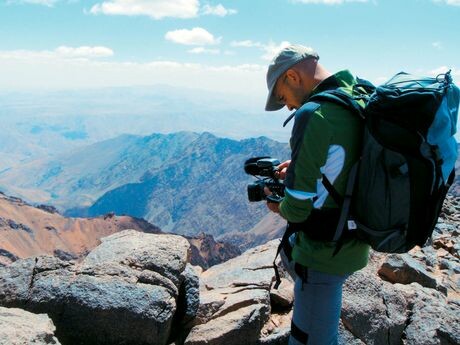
0;85;289;171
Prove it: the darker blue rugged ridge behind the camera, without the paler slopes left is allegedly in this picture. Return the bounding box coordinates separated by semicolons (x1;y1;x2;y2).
77;133;289;236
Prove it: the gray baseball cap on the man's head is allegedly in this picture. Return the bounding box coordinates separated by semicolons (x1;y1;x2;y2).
265;44;319;111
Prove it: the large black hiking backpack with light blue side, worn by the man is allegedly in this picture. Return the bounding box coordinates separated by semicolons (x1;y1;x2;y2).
275;71;459;288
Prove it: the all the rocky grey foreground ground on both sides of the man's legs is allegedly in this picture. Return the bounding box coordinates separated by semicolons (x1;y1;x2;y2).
0;197;460;345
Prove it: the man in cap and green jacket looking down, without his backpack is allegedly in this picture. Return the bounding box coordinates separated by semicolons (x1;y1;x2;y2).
265;45;369;345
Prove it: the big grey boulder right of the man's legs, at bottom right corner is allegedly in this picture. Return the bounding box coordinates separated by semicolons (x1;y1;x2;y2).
342;248;460;345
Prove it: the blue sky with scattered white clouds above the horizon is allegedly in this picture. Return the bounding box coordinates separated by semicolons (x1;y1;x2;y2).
0;0;460;105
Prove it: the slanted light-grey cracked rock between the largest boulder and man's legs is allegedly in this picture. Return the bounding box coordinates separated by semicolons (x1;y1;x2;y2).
185;240;278;345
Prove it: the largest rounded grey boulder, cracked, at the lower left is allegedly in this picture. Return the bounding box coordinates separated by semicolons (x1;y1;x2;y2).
0;230;199;344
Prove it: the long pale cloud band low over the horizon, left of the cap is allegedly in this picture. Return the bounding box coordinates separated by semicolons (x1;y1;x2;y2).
0;46;266;100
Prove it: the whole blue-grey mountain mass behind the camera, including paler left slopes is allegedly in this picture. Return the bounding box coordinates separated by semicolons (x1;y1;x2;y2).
0;132;289;236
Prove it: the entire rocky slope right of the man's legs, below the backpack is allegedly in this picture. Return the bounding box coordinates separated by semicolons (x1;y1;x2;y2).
342;197;460;345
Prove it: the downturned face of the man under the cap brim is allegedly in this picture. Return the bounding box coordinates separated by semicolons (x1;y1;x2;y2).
274;72;307;111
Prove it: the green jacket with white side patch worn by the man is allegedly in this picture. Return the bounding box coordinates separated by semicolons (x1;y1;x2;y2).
280;71;369;274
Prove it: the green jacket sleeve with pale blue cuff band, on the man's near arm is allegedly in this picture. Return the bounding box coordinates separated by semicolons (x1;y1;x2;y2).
280;103;332;223
